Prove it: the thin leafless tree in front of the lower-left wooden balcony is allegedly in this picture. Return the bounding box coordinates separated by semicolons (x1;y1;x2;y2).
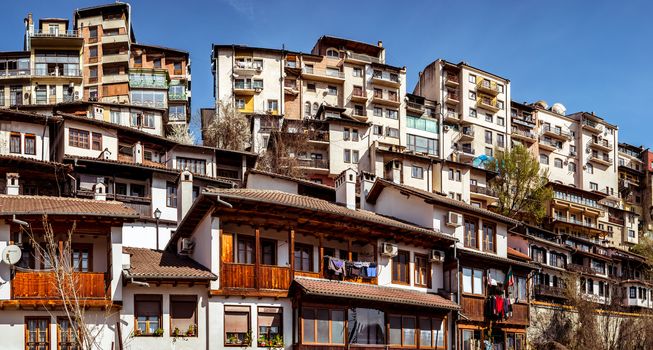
21;215;112;349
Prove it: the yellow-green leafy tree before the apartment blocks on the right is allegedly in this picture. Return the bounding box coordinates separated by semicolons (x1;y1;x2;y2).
486;145;553;223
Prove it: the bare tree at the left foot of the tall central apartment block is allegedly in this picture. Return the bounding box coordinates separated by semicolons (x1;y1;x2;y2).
203;101;251;151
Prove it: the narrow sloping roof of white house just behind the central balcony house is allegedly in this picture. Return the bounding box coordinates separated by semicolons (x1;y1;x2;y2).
367;178;519;225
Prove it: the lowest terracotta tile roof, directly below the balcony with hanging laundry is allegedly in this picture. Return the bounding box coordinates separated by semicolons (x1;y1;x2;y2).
294;277;460;310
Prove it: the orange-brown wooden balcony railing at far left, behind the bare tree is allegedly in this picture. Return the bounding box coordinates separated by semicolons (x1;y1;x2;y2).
11;272;106;299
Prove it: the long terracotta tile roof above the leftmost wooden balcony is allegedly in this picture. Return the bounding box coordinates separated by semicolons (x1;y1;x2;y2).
0;195;138;218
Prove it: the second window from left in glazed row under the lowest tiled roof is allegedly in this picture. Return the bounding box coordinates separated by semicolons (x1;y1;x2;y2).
347;308;386;344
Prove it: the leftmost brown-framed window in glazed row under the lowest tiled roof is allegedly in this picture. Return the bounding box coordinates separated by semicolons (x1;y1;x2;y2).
301;307;346;344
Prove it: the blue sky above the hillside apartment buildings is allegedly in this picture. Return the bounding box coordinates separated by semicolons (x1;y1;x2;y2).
0;0;653;147
